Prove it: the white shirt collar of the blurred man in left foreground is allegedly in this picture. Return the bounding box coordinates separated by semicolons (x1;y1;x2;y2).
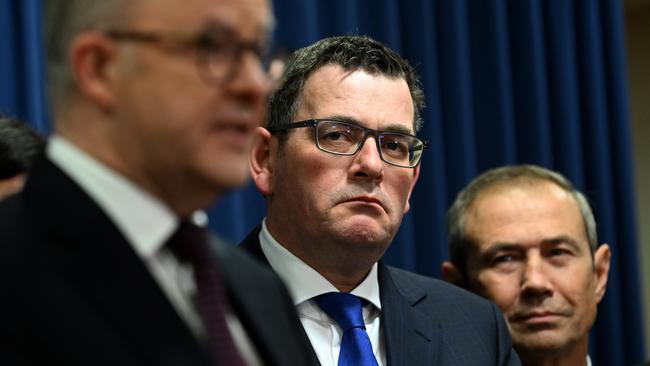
46;135;179;259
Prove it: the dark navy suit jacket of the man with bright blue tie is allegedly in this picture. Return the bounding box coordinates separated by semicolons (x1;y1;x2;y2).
240;227;521;366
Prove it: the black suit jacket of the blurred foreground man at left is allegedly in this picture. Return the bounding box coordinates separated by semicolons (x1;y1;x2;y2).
0;159;317;366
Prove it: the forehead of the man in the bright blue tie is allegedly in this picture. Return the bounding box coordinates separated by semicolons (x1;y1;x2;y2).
296;65;414;132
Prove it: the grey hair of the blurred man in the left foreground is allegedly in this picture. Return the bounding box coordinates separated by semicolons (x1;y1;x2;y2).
43;0;131;114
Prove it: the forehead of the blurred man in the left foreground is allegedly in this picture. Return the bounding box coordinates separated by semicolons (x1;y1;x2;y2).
126;0;273;38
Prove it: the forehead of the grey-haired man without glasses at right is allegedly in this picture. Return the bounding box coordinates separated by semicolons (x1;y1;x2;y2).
465;182;589;249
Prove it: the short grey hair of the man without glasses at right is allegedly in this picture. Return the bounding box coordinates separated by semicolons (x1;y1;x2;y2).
447;165;598;274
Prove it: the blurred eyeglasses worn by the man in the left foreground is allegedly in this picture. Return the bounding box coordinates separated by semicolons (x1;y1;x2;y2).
103;26;269;84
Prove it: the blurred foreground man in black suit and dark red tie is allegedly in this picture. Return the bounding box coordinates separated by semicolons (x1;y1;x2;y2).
0;0;316;366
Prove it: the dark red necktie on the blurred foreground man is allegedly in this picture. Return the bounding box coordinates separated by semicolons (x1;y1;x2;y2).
168;221;246;366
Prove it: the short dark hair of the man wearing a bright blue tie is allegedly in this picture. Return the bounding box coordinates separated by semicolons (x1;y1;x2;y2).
266;35;425;141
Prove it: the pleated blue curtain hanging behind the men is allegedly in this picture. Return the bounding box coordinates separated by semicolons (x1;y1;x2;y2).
0;0;644;365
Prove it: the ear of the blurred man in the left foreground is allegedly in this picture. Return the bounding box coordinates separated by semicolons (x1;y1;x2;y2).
70;32;118;109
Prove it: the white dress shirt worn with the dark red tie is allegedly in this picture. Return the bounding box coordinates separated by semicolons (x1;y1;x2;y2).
46;135;262;365
